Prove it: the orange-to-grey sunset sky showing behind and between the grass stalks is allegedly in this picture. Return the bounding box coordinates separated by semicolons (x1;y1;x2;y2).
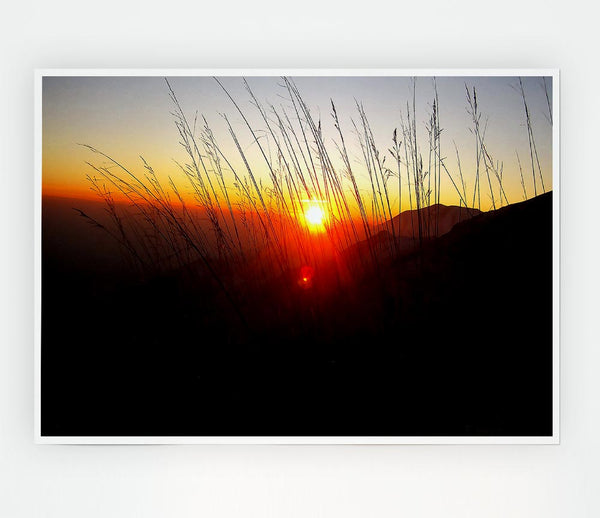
42;77;552;210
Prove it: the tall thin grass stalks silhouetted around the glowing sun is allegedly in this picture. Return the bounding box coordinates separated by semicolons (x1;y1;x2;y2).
81;77;551;338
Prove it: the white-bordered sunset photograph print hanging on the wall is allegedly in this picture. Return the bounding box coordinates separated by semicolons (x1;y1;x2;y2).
35;70;559;444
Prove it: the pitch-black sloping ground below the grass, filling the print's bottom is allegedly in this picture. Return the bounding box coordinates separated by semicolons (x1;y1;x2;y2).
42;193;552;436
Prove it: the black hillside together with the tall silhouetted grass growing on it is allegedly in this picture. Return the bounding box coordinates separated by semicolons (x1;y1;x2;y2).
42;78;552;435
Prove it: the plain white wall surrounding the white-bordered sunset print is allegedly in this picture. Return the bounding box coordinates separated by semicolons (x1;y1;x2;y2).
0;0;600;518
